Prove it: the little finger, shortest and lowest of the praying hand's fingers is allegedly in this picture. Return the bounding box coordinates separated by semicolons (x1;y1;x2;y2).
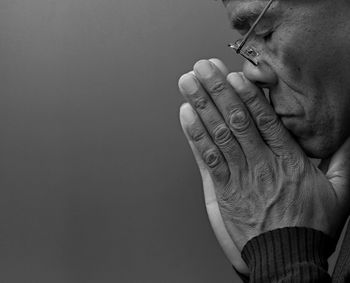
180;103;230;187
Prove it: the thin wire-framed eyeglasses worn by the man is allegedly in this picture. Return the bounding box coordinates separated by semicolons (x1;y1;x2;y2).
228;0;273;66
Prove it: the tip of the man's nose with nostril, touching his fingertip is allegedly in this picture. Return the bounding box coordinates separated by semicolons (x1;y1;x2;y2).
243;58;277;88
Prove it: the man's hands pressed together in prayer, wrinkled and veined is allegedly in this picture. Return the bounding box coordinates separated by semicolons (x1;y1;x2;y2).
179;59;350;274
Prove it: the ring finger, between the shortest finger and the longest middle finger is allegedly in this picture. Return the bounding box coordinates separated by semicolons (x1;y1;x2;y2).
179;73;245;168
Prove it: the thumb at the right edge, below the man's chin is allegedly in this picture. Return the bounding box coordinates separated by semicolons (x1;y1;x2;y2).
326;137;350;201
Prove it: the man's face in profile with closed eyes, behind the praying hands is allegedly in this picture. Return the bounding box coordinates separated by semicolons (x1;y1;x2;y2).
223;0;350;158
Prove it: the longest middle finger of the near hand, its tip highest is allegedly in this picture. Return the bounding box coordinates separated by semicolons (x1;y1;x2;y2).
194;60;269;163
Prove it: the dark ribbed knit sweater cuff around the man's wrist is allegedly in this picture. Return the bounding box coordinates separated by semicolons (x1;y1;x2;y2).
242;227;336;282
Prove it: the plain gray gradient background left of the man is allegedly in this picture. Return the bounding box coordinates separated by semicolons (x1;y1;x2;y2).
0;0;245;283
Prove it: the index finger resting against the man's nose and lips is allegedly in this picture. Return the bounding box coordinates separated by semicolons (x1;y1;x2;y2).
227;73;301;157
